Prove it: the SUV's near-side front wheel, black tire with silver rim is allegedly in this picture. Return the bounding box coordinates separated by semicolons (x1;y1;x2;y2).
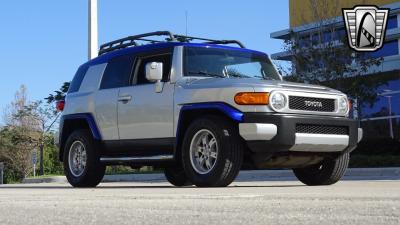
182;116;244;187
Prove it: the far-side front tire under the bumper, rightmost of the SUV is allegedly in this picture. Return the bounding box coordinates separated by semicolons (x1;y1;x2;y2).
293;153;350;186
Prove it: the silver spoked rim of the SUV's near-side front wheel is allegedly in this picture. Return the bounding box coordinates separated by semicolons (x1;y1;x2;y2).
190;129;218;174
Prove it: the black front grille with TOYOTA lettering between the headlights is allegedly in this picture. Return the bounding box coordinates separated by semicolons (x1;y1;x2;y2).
289;96;335;112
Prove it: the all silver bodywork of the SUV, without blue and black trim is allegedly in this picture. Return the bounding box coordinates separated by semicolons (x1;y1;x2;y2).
63;46;362;153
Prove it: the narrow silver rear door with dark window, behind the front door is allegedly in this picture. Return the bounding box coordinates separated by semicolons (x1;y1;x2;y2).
94;55;134;141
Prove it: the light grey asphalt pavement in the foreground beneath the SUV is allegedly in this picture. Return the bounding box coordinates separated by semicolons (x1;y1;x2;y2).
0;179;400;225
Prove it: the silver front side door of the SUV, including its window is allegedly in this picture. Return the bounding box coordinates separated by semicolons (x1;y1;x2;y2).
118;49;174;141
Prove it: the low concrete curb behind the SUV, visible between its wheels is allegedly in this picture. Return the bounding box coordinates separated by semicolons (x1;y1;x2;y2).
22;167;400;184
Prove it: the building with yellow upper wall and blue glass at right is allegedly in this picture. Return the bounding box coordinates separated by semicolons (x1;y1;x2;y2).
270;0;400;140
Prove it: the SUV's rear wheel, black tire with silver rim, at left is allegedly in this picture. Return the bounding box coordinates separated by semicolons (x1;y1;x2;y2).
63;130;106;187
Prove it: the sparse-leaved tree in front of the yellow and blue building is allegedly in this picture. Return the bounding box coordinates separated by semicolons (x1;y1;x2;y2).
280;0;386;110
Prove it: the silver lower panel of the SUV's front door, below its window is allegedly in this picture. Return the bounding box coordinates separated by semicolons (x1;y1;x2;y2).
118;83;174;139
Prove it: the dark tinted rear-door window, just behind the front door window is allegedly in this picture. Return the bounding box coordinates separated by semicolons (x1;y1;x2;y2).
100;55;134;89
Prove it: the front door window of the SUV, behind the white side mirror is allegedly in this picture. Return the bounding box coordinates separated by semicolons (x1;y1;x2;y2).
133;53;172;84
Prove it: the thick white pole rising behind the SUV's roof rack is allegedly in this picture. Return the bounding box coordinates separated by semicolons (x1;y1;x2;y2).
88;0;98;60
